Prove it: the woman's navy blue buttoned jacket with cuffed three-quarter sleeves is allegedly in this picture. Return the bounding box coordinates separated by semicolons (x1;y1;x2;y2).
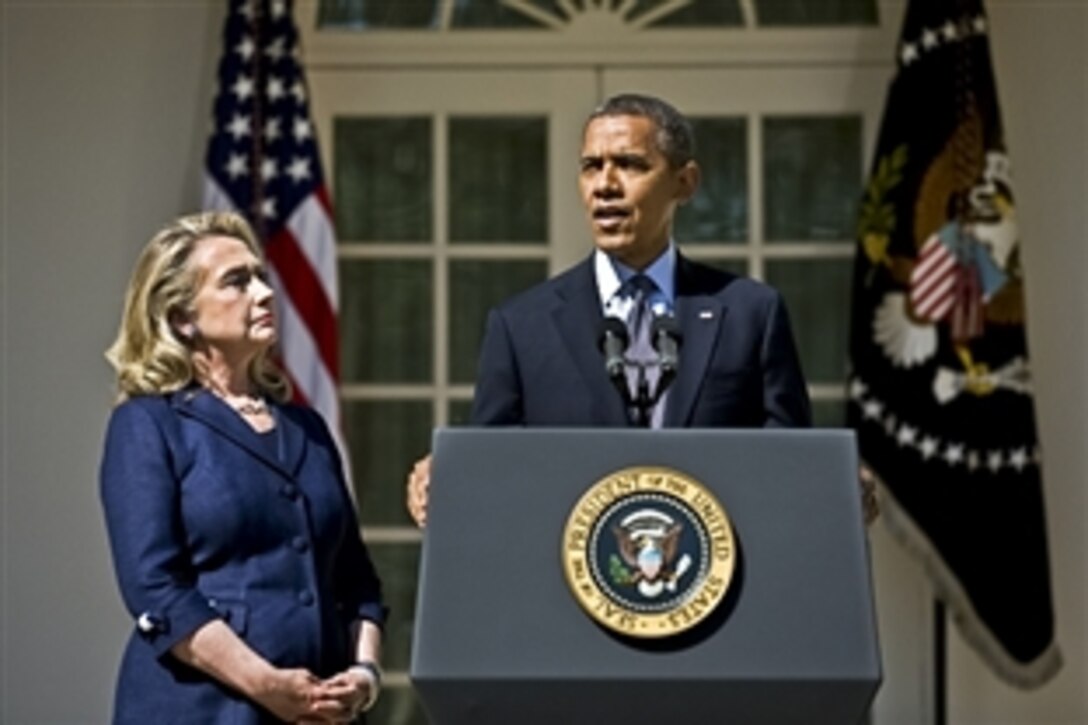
100;388;384;724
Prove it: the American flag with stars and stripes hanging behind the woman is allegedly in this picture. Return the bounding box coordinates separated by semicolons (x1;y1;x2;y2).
203;0;339;432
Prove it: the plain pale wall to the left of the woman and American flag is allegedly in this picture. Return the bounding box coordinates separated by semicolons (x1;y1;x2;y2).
0;1;222;724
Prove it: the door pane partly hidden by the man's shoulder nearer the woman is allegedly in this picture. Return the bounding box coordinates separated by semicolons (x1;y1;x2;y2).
449;259;547;383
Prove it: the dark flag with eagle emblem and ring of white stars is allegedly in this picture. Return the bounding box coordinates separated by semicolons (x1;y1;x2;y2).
849;0;1061;688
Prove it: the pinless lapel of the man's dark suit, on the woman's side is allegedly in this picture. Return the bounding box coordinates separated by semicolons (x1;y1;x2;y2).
552;255;628;426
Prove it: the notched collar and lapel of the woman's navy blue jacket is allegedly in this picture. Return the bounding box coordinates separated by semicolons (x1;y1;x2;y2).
172;388;306;478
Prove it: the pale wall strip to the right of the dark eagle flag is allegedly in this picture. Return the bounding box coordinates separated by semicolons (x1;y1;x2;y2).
949;0;1088;725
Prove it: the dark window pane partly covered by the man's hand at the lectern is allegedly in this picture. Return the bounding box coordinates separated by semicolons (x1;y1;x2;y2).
342;401;434;526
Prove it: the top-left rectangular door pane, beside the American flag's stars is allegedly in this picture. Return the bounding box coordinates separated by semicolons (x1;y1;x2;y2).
333;118;433;244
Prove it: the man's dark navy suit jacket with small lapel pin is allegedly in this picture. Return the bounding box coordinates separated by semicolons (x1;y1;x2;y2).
472;255;811;428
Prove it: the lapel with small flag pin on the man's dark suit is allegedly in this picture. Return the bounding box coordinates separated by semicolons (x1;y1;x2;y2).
665;256;728;428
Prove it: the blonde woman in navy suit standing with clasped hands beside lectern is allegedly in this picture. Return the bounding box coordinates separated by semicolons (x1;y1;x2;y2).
100;213;386;725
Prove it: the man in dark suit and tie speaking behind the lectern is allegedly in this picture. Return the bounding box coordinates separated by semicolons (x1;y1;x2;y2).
408;95;811;525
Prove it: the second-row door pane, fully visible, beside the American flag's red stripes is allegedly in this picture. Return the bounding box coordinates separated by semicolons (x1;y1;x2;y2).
339;260;433;383
